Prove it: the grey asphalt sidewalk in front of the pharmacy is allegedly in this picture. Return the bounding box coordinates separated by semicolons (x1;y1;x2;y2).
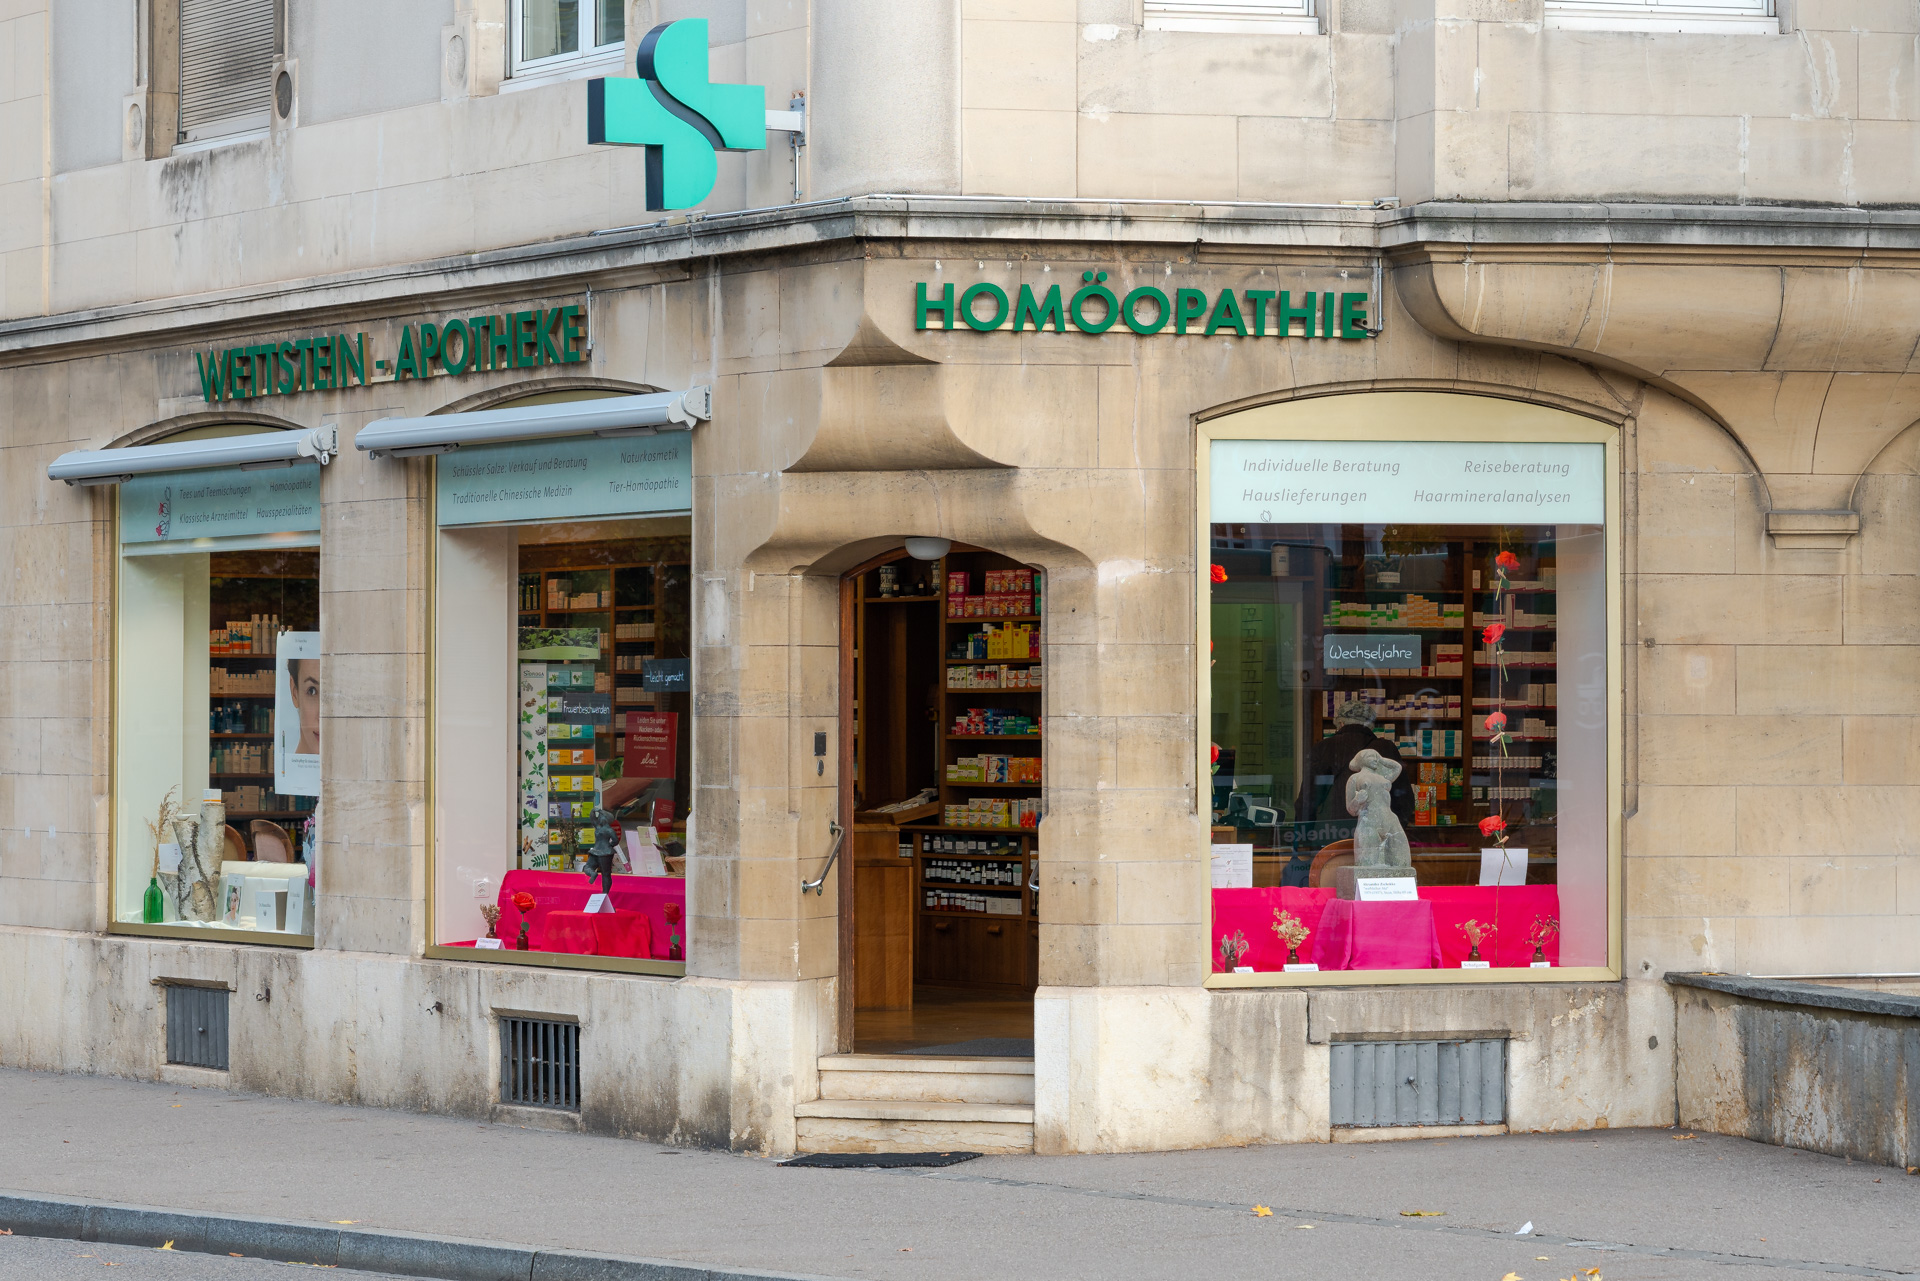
0;1072;1920;1281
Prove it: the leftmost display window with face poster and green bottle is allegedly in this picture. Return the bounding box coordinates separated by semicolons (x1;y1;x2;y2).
111;451;323;945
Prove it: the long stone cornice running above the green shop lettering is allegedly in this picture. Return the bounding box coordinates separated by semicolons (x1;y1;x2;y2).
0;196;1920;367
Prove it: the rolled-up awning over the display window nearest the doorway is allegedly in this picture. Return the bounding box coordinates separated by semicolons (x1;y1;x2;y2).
353;386;712;457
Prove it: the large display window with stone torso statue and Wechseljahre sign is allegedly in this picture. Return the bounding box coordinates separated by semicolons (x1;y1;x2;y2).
1204;398;1617;978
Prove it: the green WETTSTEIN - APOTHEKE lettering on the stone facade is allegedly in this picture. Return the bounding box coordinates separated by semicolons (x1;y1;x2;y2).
194;305;586;403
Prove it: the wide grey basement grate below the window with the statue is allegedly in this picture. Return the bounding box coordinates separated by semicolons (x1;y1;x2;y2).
1329;1039;1507;1125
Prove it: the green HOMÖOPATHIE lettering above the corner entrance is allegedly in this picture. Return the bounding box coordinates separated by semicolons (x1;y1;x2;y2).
914;271;1373;338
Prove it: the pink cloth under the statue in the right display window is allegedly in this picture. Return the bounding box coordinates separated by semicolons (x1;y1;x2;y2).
1212;885;1559;974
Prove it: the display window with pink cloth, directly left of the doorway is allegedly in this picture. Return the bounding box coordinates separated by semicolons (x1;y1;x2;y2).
434;420;693;974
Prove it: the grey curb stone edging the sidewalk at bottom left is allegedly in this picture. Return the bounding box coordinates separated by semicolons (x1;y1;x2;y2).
0;1193;835;1281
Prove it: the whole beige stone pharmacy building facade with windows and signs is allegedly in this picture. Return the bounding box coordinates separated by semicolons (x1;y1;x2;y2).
0;0;1920;1154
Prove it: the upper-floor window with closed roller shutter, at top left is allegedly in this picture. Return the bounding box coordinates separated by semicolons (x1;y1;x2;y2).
175;0;280;142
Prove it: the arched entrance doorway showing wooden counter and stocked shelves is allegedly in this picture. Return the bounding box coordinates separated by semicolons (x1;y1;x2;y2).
839;540;1046;1058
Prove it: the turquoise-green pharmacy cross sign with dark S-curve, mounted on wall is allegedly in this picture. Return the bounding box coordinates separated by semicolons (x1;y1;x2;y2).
588;17;768;209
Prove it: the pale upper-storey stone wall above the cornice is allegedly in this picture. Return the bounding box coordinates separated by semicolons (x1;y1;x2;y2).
0;0;1920;317
